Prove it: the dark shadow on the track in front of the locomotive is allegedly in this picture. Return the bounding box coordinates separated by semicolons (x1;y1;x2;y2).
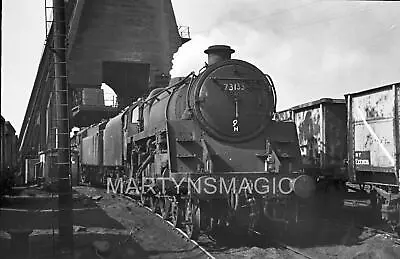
198;199;390;252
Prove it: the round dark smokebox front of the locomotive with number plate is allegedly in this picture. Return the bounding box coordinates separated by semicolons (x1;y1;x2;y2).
190;57;275;142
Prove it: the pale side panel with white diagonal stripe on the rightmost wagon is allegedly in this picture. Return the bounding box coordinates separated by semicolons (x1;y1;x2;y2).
350;88;397;185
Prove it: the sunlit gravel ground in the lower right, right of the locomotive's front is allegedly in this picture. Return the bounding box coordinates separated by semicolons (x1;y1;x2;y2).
200;207;400;259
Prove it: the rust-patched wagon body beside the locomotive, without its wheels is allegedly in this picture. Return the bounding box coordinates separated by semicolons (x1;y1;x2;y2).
277;98;347;181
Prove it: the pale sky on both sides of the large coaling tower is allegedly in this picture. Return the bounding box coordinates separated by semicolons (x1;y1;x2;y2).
1;0;400;136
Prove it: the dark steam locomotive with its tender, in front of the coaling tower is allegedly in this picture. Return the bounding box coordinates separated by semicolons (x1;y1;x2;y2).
76;45;314;242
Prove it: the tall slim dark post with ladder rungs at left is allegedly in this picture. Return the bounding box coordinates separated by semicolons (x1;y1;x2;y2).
53;0;73;251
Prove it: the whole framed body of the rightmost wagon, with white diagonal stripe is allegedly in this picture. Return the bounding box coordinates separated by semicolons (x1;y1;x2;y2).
346;83;400;192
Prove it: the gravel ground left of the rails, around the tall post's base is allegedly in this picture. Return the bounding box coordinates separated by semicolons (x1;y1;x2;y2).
0;187;205;259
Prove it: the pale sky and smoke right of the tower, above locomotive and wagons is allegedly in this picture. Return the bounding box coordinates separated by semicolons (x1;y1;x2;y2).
171;0;400;110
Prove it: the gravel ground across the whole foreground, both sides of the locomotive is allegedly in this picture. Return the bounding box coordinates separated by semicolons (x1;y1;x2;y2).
0;187;400;259
